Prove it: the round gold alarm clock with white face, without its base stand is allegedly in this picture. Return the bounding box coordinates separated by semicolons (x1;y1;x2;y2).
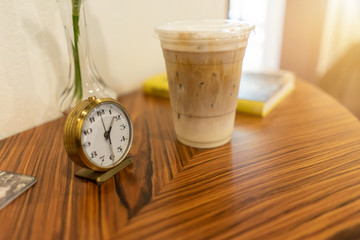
64;97;133;172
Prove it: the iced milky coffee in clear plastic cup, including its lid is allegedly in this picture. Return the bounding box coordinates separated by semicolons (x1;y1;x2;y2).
156;20;254;148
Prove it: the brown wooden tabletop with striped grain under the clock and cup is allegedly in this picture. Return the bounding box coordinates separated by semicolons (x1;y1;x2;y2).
0;80;360;239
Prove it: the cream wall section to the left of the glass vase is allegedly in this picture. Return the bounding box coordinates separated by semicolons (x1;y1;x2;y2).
0;0;67;138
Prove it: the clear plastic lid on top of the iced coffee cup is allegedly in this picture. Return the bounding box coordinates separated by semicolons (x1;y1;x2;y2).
155;19;255;40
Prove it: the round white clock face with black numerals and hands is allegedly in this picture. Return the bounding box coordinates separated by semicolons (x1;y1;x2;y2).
81;102;132;168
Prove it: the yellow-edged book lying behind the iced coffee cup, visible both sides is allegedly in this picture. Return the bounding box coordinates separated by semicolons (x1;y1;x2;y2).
143;71;295;117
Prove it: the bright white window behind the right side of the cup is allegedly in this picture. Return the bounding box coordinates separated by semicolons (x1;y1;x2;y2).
229;0;286;70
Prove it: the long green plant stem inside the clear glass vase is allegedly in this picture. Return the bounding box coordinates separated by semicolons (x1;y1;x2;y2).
72;0;83;102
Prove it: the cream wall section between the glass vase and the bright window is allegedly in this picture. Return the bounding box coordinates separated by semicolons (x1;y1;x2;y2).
88;0;227;93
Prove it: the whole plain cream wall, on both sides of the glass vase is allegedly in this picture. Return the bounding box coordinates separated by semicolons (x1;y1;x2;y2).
0;0;227;139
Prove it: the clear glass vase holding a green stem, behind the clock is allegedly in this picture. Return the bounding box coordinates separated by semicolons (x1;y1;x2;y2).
57;0;117;114
